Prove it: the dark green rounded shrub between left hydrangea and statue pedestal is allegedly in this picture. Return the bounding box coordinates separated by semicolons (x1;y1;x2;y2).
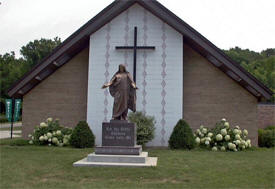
70;121;95;148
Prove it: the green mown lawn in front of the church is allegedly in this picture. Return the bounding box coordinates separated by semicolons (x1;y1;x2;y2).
0;139;275;189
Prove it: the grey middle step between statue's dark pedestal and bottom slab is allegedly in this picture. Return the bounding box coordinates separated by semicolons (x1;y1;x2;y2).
87;152;148;163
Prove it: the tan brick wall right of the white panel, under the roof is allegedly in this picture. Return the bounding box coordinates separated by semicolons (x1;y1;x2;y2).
183;45;258;145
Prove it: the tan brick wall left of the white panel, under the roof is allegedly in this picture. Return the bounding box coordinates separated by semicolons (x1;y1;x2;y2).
22;48;89;138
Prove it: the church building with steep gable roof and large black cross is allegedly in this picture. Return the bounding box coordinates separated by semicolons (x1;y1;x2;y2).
8;0;272;146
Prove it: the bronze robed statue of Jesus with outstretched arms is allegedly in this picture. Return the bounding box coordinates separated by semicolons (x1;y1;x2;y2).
102;64;138;120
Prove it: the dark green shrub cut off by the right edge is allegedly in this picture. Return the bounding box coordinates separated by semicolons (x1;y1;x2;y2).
258;126;275;148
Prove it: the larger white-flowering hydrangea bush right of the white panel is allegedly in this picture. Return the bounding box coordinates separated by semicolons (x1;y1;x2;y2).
194;118;251;152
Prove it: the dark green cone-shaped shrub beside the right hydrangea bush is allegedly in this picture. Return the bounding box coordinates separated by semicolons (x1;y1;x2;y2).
168;119;195;150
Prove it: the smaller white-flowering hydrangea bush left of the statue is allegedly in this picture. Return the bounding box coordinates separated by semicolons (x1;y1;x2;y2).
29;118;72;147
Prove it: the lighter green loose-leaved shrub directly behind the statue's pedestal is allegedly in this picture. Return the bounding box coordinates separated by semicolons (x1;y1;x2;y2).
129;112;155;145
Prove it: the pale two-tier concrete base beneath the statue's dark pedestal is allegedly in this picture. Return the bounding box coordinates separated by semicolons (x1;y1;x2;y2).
73;152;158;167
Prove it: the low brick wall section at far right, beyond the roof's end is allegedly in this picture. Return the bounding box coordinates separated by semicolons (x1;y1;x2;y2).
257;104;275;129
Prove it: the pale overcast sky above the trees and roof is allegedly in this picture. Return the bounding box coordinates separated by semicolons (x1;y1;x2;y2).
0;0;275;57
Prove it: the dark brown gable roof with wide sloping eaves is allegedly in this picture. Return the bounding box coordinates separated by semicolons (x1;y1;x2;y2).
8;0;273;99
